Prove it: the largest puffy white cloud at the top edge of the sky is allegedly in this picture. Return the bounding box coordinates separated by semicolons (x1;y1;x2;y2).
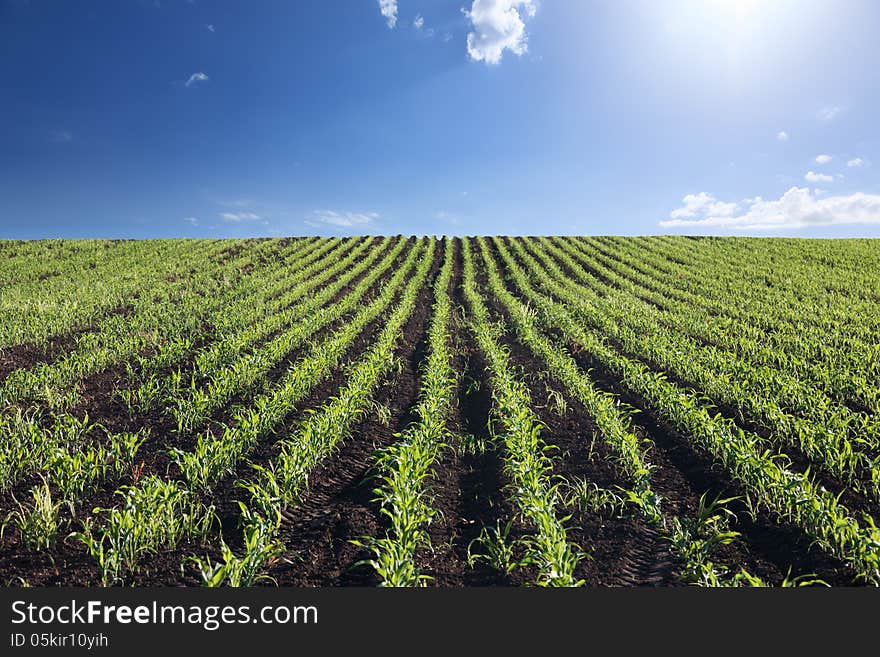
464;0;537;64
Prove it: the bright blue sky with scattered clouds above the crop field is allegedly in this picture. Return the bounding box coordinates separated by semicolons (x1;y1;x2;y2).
0;0;880;238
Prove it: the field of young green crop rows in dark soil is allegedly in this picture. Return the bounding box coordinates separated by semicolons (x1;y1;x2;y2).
0;237;880;586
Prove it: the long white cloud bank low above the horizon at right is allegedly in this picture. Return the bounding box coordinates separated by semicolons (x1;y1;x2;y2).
660;187;880;230
